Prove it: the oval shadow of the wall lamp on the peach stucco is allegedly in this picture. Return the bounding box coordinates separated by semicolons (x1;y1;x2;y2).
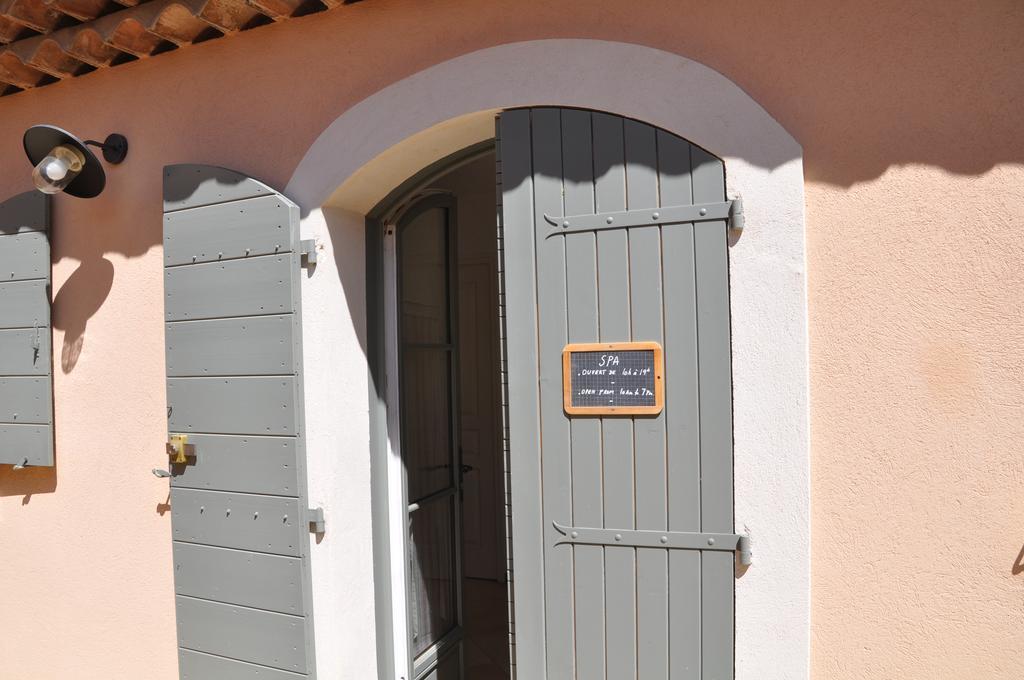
53;257;114;373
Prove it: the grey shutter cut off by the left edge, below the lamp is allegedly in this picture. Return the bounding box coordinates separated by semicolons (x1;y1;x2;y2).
0;192;53;466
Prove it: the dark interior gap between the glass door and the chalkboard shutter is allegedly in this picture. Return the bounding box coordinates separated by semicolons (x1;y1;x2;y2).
399;151;511;680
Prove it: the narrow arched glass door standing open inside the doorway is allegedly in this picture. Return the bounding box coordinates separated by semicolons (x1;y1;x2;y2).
396;195;463;680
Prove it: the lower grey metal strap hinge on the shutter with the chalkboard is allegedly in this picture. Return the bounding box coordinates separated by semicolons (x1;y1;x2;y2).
551;522;753;566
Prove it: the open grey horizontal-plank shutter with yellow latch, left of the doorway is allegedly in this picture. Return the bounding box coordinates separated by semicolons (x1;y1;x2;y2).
164;165;314;680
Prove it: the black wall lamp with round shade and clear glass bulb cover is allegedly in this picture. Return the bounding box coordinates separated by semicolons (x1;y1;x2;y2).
23;125;128;199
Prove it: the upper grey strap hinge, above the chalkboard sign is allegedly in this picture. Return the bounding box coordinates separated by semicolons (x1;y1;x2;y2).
544;197;743;239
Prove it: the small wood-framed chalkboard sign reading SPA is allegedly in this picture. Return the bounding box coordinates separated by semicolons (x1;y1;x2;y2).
562;342;665;416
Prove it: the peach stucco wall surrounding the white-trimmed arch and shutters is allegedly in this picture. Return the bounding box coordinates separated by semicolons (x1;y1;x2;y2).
0;0;1024;680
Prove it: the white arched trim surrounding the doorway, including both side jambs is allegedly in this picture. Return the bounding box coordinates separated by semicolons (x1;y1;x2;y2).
286;39;810;680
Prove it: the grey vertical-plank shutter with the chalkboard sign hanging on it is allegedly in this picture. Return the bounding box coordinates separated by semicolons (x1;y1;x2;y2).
498;109;738;680
